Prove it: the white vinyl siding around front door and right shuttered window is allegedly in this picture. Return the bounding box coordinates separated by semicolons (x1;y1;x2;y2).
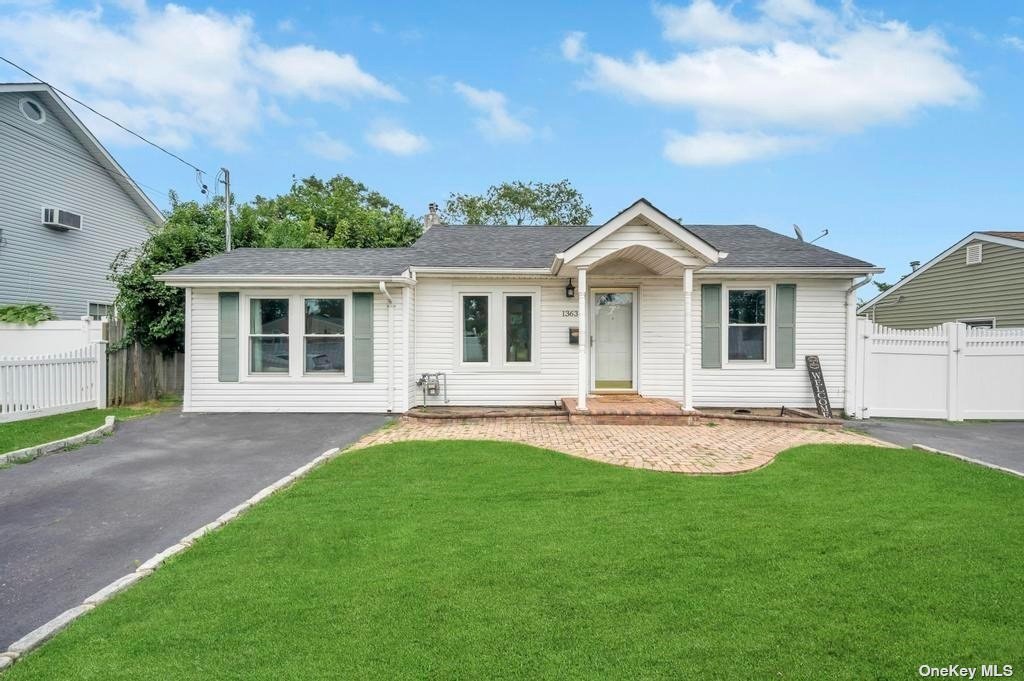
412;278;850;409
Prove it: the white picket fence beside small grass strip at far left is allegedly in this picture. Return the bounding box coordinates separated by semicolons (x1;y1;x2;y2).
0;341;106;423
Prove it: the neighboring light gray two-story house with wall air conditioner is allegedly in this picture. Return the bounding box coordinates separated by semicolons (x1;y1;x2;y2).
0;83;164;320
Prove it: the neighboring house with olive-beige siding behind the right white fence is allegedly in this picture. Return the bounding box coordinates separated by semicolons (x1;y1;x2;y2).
857;231;1024;329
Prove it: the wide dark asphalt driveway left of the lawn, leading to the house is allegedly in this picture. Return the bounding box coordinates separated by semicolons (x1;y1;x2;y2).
0;412;386;650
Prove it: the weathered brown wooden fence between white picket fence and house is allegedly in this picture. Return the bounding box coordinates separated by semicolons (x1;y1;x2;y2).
106;320;185;407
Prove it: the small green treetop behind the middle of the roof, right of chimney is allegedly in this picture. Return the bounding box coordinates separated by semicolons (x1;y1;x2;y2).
441;179;594;224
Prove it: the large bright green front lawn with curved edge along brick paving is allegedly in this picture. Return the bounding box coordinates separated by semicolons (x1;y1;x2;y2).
4;442;1024;681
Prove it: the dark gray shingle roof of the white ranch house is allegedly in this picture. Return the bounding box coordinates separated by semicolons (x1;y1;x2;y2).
159;224;872;276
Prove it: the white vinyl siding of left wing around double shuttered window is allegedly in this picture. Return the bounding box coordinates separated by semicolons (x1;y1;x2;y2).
185;289;410;412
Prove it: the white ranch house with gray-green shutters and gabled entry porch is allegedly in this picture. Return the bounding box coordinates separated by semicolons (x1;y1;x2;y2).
162;199;882;413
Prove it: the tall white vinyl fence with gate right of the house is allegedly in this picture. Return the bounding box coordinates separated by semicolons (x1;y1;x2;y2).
849;317;1024;421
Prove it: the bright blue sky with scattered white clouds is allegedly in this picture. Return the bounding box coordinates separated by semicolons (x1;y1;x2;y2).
0;0;1024;280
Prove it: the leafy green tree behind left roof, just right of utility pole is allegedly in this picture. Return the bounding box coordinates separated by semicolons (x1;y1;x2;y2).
237;175;423;248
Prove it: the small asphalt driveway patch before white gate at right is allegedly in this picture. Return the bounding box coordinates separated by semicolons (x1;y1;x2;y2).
847;419;1024;474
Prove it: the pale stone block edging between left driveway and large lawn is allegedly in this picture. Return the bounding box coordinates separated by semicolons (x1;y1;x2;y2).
0;444;341;670
